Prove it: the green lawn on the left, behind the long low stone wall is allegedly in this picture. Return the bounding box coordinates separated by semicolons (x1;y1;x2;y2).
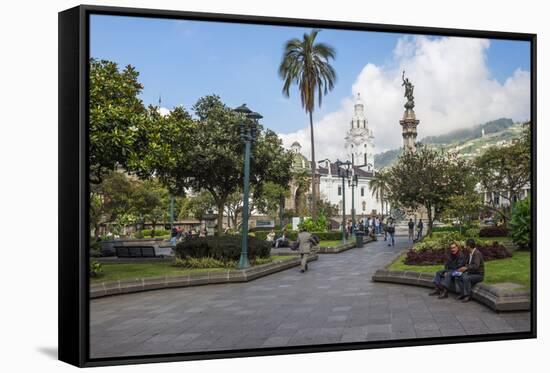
90;255;296;284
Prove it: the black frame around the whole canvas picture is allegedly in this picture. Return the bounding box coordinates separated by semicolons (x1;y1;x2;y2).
58;5;537;367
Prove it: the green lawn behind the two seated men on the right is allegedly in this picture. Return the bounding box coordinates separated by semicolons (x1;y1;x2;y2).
388;251;531;289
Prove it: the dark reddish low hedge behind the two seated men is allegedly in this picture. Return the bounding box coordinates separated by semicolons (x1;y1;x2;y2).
405;242;512;265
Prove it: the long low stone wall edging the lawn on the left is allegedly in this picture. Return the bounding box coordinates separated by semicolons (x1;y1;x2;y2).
90;255;318;299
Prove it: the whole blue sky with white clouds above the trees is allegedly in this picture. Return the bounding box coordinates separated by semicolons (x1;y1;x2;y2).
90;16;530;159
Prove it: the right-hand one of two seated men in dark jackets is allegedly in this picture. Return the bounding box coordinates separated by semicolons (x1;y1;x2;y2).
456;238;485;302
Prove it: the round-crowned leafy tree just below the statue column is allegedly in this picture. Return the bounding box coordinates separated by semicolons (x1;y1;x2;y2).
388;146;475;236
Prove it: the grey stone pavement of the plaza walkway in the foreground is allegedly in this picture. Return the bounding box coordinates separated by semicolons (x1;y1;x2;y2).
90;237;530;358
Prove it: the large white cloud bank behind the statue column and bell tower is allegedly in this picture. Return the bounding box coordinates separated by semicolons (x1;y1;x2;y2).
280;36;530;159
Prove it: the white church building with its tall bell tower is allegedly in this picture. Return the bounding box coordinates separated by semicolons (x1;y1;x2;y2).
291;95;386;218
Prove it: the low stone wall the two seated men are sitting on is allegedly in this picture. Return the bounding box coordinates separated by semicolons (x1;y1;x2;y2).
372;269;531;312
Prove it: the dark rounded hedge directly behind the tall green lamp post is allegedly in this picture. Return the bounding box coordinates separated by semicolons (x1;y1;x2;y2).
175;232;271;263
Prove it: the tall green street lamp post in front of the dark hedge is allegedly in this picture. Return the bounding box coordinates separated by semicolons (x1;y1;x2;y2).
235;104;262;268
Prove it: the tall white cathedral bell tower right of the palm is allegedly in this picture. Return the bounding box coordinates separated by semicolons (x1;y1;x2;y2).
344;93;374;172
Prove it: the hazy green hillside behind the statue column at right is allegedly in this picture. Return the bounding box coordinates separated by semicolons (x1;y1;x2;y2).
374;118;521;169
